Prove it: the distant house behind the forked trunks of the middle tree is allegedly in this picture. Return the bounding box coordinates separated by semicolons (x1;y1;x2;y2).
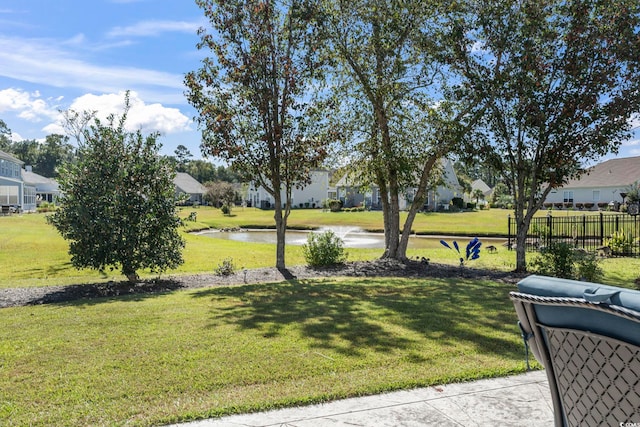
336;159;462;210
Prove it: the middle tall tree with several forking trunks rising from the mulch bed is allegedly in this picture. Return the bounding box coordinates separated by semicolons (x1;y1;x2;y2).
315;0;462;259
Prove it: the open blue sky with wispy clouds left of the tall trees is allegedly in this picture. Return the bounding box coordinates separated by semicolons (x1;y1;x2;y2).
0;0;206;158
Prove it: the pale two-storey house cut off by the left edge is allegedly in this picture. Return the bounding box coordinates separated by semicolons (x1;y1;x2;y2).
0;151;36;212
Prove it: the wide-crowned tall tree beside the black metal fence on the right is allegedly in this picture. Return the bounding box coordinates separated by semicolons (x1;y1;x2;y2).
449;0;640;271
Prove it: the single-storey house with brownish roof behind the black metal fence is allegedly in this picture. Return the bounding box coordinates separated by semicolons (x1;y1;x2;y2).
545;157;640;209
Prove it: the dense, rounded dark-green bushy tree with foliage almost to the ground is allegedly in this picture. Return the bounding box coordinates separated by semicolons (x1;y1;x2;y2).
48;93;184;282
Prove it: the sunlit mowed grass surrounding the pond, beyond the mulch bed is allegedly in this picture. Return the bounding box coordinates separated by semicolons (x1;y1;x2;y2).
0;207;640;289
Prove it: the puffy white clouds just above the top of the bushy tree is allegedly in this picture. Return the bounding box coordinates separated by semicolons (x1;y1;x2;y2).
44;92;191;134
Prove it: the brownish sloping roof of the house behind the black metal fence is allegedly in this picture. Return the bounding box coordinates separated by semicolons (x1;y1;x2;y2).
562;156;640;188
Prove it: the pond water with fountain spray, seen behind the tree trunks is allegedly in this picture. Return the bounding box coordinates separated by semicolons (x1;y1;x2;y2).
198;227;506;249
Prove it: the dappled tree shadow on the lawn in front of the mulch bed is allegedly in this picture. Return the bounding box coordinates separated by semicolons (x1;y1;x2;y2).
194;278;522;362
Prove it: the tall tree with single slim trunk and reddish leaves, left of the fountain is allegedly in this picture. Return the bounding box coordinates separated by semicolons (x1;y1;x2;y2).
185;0;326;268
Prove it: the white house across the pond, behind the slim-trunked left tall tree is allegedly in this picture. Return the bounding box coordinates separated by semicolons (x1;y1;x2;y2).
245;169;331;209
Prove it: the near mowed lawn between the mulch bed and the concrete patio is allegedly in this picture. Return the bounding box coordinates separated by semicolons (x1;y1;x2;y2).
0;278;525;426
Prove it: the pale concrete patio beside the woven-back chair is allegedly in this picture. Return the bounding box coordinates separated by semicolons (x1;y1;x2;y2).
174;371;553;427
